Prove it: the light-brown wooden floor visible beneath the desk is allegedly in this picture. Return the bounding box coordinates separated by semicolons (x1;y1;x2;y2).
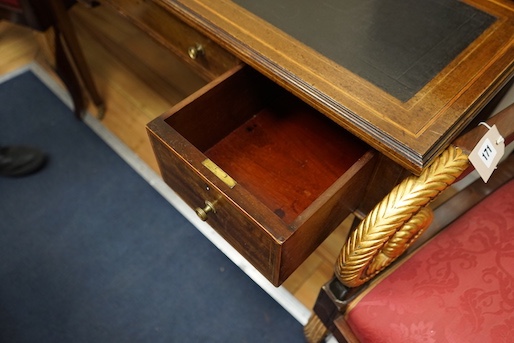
0;4;349;314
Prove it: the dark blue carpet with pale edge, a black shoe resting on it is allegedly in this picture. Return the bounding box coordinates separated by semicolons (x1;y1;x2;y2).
0;72;304;343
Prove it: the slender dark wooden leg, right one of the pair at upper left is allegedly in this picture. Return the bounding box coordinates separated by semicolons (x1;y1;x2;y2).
49;0;105;119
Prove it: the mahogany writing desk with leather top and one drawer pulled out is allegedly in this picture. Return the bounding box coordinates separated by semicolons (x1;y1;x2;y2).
104;0;514;285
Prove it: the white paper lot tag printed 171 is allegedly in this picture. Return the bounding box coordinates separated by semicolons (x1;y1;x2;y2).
469;123;505;182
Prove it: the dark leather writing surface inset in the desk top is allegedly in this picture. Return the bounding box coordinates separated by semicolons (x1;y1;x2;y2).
233;0;495;101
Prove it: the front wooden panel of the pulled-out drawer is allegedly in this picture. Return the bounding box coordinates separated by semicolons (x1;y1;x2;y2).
148;125;280;281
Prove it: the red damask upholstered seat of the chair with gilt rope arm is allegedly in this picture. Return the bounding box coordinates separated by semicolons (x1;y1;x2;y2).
347;180;514;343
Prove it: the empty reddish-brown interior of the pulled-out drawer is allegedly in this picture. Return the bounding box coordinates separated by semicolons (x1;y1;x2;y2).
165;67;369;225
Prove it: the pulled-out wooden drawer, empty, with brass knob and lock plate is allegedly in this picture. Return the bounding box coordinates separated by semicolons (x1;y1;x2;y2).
147;66;374;286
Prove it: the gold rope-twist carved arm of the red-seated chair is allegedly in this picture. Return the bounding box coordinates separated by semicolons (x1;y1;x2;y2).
335;146;468;287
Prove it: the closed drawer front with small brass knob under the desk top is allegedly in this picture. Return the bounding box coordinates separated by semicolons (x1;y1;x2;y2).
102;0;239;80
